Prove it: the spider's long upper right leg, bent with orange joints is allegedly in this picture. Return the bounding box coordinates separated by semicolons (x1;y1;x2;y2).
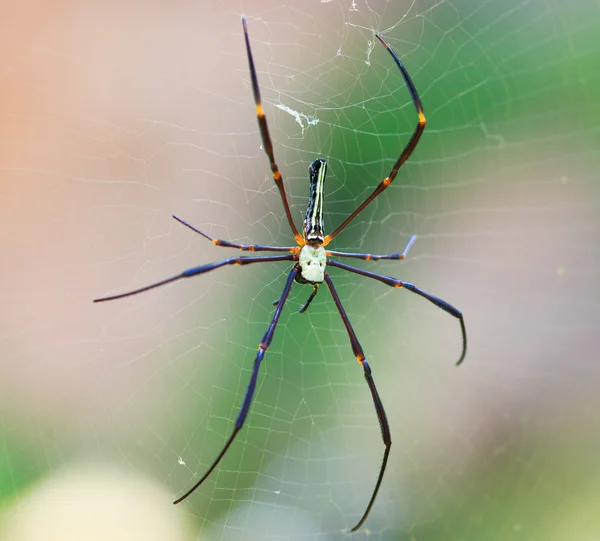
323;34;427;246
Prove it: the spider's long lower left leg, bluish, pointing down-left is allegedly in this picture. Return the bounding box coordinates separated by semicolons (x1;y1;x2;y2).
173;266;298;504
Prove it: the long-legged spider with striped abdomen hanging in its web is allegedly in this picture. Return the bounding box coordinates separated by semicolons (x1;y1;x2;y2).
94;18;467;532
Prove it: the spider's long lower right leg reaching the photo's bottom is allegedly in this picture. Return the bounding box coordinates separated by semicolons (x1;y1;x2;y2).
325;272;392;532
